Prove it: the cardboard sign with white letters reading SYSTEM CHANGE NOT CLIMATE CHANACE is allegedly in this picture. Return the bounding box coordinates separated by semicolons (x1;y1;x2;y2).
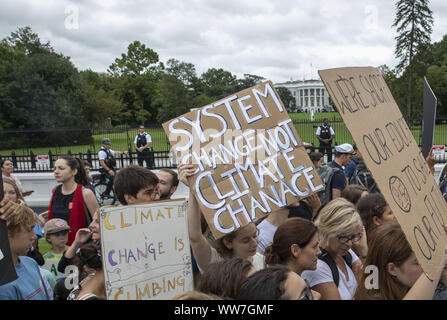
163;81;323;238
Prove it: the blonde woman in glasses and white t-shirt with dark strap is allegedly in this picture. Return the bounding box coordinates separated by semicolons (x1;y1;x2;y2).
301;198;363;300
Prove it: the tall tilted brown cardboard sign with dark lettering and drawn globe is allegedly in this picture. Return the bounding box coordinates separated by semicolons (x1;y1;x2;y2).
319;67;447;279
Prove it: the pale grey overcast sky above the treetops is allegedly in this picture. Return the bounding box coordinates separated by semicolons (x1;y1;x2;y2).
0;0;447;82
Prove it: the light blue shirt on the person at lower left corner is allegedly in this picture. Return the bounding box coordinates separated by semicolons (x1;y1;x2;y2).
0;256;52;300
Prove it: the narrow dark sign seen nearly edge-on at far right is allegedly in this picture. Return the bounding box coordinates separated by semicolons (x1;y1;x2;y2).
422;77;438;158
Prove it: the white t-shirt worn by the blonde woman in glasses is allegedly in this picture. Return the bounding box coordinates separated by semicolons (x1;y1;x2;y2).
301;249;359;300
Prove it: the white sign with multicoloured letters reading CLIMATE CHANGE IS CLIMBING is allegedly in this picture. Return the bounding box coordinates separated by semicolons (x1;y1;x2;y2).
100;200;193;300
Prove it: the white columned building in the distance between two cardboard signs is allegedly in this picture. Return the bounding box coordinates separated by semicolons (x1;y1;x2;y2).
275;80;334;113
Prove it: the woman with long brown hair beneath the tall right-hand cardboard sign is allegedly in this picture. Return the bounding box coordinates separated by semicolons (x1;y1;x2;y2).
354;222;447;300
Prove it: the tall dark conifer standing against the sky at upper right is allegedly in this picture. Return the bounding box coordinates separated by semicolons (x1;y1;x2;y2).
393;0;433;117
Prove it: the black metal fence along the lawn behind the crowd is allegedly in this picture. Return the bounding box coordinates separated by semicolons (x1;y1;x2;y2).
0;118;447;172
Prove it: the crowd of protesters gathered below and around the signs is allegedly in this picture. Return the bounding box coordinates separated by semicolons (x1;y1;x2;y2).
0;134;447;300
